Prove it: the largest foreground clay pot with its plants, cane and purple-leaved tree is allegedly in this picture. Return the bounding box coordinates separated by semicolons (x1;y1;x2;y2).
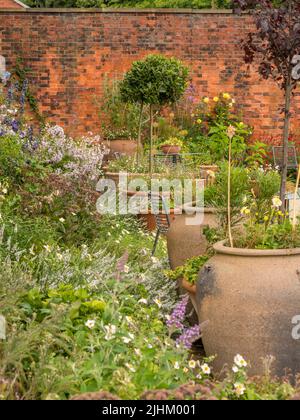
197;0;300;377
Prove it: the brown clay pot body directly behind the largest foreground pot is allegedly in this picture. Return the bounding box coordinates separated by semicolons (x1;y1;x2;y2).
167;204;218;270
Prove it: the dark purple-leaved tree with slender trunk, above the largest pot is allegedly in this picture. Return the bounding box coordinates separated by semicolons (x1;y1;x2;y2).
234;0;300;210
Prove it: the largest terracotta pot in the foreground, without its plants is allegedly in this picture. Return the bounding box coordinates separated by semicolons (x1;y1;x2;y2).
196;242;300;376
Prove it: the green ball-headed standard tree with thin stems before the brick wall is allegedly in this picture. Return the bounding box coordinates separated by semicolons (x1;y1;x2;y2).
120;54;189;173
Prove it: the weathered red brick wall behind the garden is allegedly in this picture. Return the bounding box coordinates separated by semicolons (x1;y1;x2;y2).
0;9;300;137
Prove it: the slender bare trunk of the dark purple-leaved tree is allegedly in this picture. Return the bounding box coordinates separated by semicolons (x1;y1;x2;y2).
280;77;292;212
